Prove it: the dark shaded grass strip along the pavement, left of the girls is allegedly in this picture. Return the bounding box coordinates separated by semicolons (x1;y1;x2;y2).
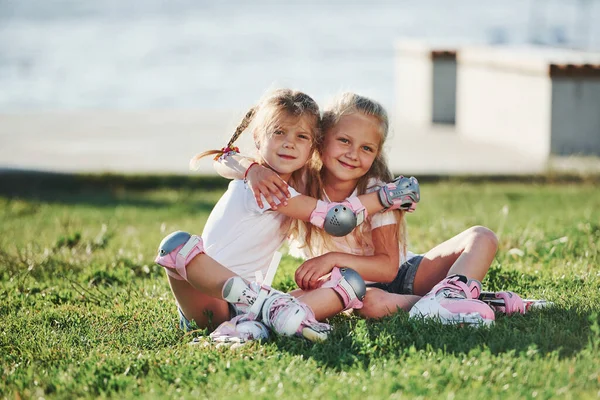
0;171;229;212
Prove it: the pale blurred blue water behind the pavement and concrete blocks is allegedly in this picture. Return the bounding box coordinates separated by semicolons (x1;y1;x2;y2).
0;0;600;112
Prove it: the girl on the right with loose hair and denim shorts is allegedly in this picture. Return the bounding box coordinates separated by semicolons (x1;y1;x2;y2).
237;93;504;324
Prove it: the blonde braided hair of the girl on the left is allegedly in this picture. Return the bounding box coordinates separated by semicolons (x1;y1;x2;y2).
190;89;322;191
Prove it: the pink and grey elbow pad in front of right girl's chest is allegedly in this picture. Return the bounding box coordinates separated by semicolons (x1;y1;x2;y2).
310;197;367;236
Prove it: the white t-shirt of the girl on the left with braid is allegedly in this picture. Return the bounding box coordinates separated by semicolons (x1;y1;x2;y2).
202;180;299;280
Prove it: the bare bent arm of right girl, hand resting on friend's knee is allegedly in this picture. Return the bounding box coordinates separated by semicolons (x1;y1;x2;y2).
294;224;400;290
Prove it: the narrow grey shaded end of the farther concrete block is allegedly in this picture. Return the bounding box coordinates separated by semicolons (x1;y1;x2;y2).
430;58;456;124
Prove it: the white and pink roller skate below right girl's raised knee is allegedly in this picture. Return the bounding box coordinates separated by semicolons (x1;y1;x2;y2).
410;275;495;325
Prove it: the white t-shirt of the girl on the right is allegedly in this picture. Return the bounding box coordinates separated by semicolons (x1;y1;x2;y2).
289;179;415;268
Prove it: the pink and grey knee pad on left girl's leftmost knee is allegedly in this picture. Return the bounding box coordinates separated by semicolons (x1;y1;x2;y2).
154;231;204;281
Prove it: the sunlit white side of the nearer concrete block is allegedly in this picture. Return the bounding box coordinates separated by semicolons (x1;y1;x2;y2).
456;61;551;158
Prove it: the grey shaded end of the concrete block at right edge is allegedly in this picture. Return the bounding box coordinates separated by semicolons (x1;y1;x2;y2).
550;77;600;156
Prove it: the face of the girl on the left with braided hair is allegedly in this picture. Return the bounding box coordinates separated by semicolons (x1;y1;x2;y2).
258;114;315;181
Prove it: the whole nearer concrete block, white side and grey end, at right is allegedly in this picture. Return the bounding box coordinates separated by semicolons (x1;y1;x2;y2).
456;46;600;159
